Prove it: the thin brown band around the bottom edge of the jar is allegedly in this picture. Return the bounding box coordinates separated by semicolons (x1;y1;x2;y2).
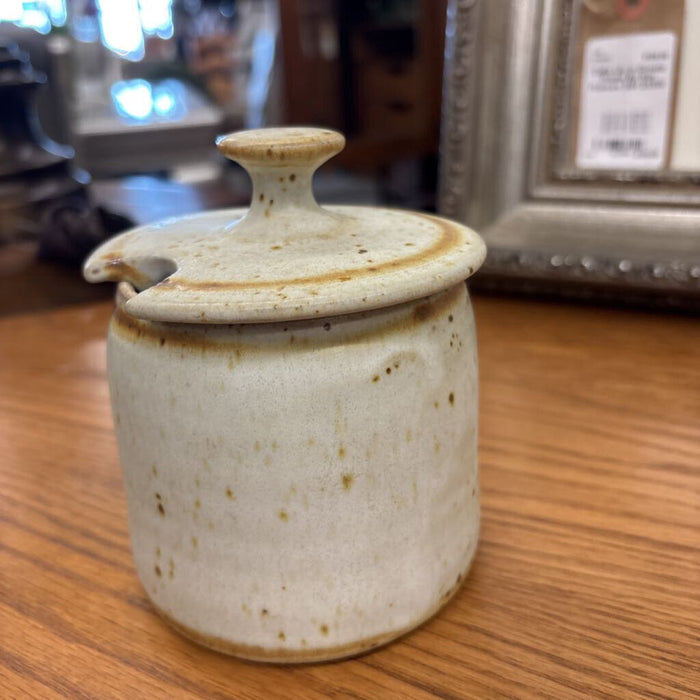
151;555;474;664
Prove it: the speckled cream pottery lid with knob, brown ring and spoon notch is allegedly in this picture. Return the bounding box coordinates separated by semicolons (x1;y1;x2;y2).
84;127;486;323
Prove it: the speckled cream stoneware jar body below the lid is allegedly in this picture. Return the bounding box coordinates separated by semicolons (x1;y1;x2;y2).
108;283;479;661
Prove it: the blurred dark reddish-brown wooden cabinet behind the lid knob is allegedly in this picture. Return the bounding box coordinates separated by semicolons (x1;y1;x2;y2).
280;0;446;170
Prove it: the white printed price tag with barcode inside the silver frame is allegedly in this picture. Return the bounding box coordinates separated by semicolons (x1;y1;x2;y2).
576;32;676;170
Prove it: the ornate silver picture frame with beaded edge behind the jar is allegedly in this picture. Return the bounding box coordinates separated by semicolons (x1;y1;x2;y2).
439;0;700;308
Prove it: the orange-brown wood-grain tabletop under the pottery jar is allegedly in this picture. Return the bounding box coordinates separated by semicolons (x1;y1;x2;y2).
0;297;700;700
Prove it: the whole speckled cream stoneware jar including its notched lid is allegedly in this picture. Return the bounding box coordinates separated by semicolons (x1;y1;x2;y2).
85;128;485;662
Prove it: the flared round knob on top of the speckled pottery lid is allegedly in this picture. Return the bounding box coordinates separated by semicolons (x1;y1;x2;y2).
216;127;345;232
